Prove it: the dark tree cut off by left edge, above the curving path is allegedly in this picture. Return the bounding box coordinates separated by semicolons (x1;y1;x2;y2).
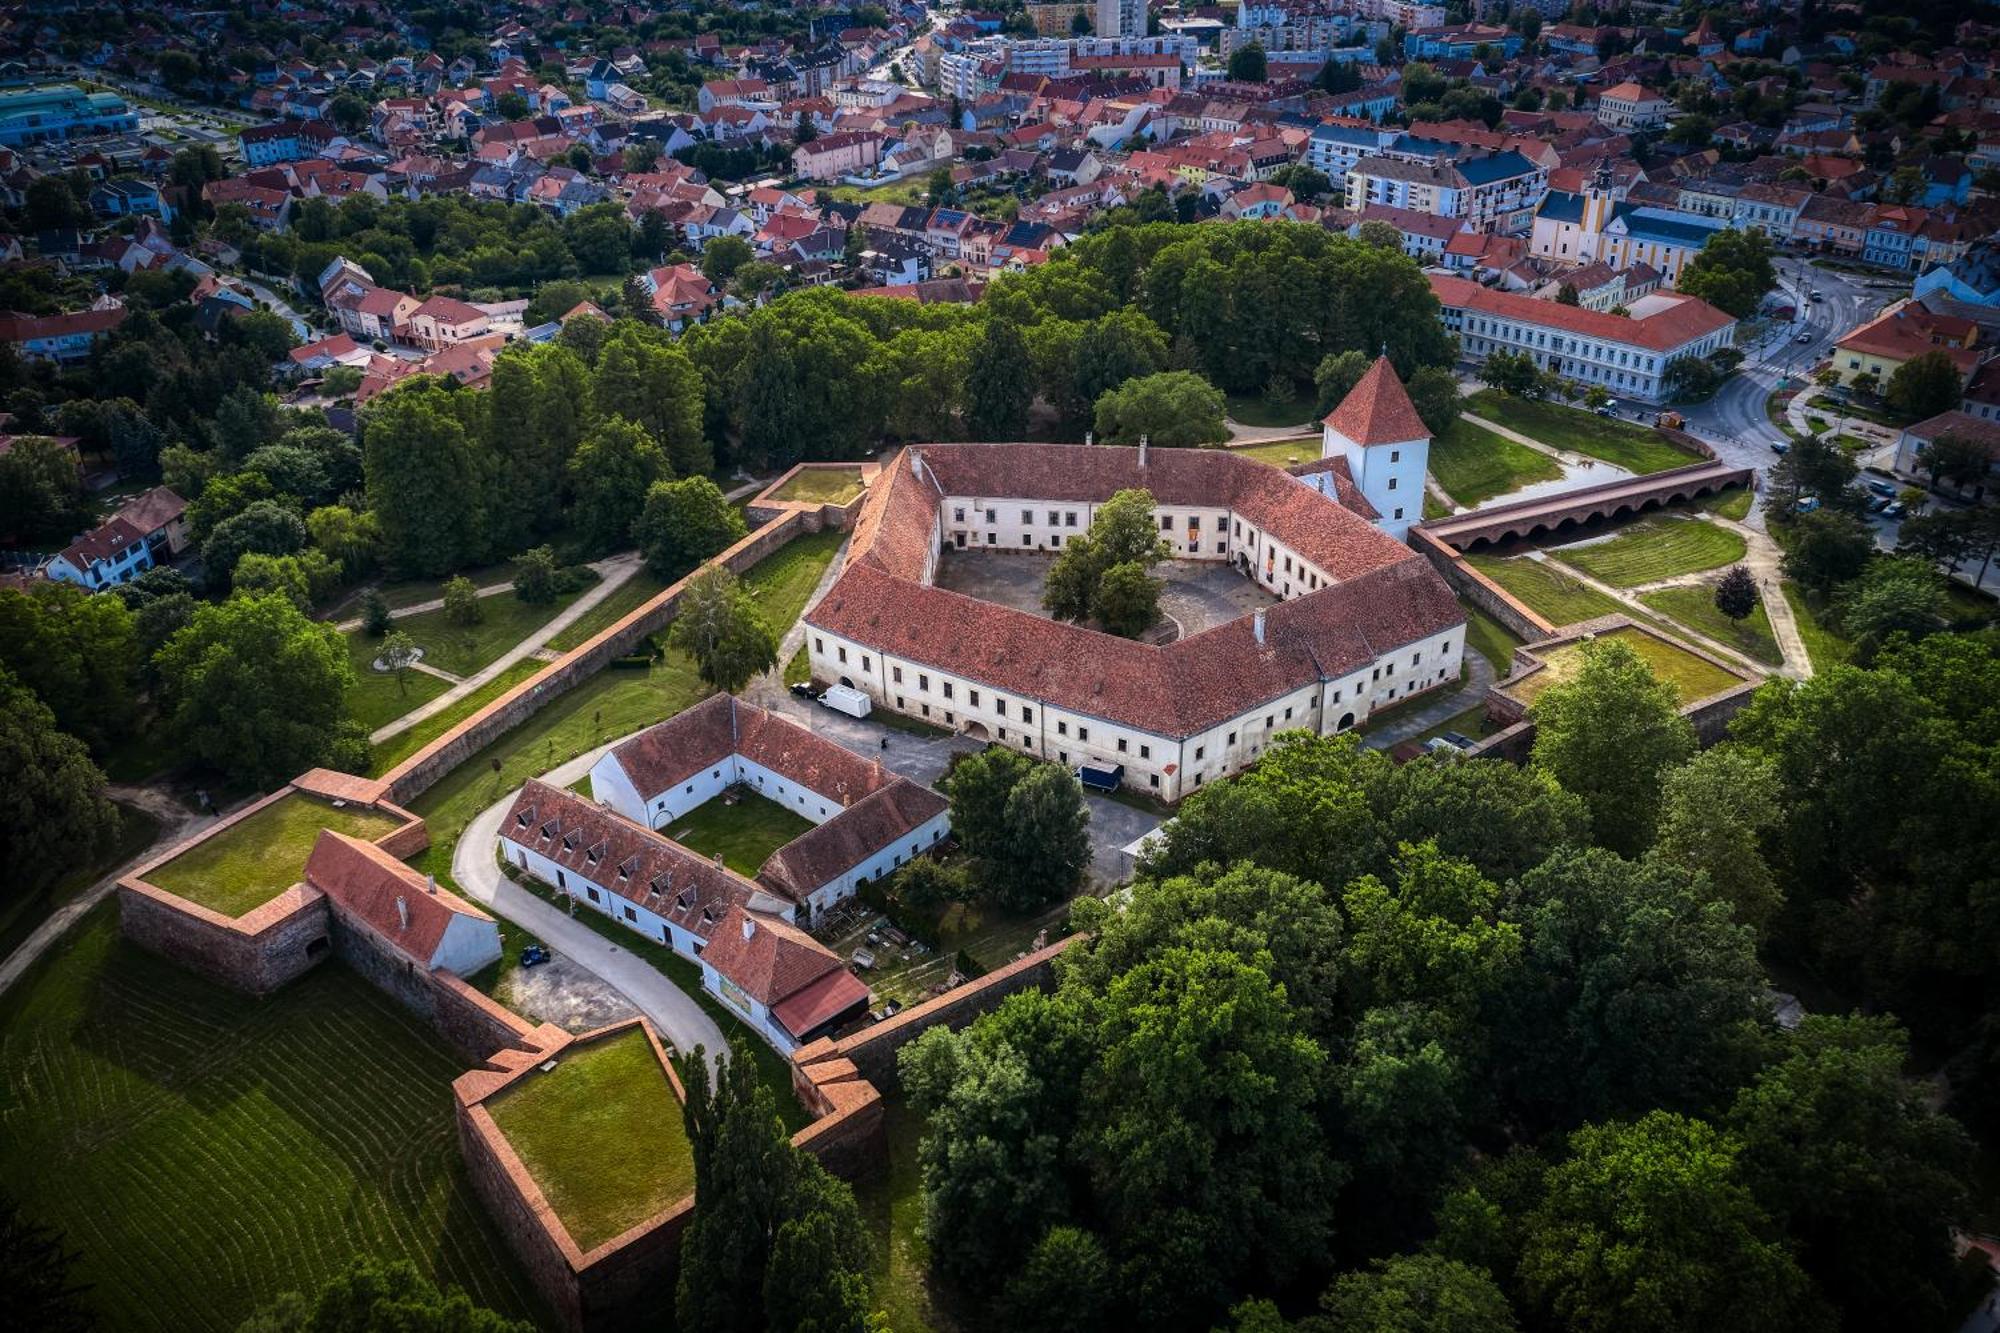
0;667;118;896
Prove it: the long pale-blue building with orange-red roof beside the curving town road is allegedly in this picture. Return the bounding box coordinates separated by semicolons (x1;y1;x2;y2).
1430;274;1736;402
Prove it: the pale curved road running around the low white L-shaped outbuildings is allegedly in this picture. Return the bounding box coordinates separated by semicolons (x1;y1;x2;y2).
452;737;728;1061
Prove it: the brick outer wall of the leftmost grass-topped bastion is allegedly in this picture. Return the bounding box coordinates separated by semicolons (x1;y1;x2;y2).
118;879;330;995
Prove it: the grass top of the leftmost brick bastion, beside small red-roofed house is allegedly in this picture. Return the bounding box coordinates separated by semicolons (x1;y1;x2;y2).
146;791;398;917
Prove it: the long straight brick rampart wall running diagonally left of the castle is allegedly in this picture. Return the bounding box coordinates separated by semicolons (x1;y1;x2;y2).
382;510;816;805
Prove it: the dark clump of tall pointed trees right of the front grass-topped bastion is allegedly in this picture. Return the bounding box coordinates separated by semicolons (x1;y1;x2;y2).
674;1041;870;1333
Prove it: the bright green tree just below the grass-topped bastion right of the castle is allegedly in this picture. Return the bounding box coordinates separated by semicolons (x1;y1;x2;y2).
1528;640;1694;855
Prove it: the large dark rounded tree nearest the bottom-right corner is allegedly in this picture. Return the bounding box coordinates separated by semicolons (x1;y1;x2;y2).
1726;1015;1970;1333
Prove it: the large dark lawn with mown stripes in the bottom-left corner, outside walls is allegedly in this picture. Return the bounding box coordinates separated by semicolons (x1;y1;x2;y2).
0;905;546;1333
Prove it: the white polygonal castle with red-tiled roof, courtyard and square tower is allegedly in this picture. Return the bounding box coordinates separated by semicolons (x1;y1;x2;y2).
806;362;1464;801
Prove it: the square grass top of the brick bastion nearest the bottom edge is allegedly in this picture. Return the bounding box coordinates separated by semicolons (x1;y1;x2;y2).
486;1027;694;1253
